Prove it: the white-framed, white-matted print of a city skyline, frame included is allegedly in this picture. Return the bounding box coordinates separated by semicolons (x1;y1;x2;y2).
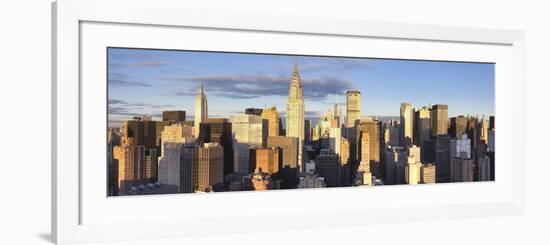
52;0;524;243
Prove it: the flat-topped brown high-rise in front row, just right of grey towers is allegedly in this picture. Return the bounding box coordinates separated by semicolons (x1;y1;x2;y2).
194;143;223;192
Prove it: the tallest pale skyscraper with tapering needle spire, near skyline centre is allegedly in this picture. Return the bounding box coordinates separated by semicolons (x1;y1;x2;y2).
286;65;305;171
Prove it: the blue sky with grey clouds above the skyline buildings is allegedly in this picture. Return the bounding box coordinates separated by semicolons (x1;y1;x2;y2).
108;48;495;125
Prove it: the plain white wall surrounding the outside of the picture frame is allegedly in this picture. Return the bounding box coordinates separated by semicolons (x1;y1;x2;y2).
0;0;550;245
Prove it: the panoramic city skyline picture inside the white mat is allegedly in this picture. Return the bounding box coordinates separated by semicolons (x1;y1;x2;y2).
106;47;495;196
